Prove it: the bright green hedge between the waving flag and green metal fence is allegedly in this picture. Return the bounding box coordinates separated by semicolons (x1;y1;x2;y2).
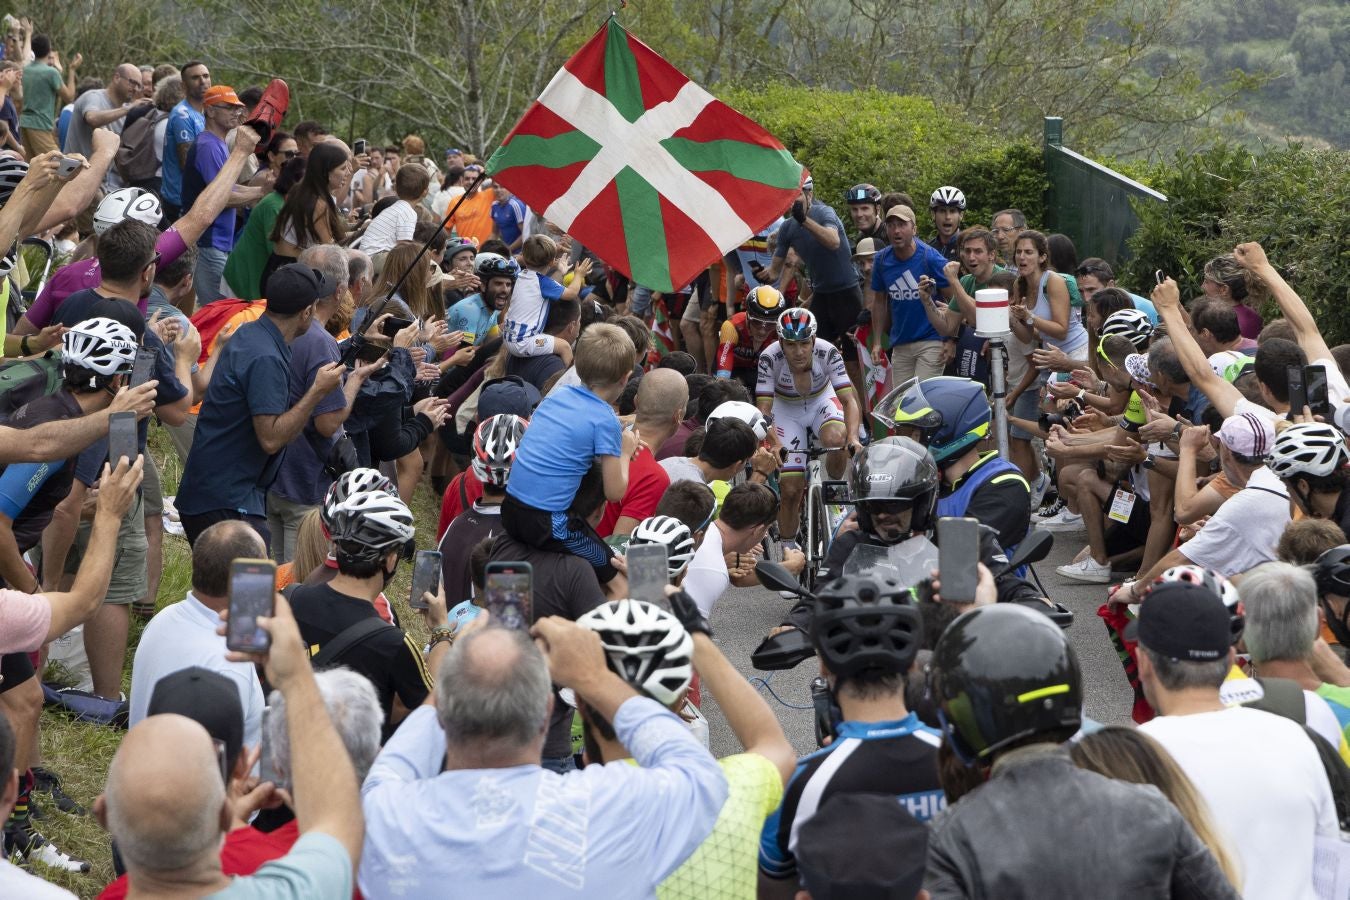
720;84;1046;235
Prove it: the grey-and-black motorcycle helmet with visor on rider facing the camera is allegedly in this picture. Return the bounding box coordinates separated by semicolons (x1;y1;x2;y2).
848;437;940;544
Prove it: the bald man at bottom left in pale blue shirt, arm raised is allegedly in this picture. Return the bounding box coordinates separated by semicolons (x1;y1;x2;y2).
95;594;363;897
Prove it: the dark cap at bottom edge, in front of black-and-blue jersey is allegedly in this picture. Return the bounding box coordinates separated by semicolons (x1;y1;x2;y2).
797;793;927;900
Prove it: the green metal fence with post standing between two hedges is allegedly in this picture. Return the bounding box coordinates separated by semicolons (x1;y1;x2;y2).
1045;117;1168;266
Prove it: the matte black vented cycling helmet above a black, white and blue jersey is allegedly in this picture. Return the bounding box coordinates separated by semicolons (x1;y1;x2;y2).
811;575;923;680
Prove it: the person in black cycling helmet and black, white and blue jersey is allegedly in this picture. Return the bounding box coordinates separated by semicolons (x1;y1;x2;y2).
760;578;946;897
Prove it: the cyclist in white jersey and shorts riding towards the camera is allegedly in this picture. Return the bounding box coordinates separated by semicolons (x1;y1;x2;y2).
755;309;863;537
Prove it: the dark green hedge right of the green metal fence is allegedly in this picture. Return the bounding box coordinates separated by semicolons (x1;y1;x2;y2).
1122;146;1350;344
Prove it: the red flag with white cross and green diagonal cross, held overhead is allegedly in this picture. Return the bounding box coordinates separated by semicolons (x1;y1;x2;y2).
487;18;802;291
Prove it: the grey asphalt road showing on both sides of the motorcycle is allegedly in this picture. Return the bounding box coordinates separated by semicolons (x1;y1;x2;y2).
703;534;1134;757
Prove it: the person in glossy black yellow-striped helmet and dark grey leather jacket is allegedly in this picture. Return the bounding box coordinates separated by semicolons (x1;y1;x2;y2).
923;604;1238;900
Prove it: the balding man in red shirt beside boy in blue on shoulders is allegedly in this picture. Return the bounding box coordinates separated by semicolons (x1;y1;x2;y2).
595;368;689;537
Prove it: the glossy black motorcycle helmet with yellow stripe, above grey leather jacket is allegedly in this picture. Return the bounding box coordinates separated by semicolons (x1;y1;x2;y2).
929;603;1083;765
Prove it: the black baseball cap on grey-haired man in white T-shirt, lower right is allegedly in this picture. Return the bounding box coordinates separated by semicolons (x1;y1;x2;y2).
1125;582;1233;663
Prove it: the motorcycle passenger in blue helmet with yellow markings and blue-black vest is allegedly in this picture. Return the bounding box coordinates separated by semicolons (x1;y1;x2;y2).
873;375;1031;553
